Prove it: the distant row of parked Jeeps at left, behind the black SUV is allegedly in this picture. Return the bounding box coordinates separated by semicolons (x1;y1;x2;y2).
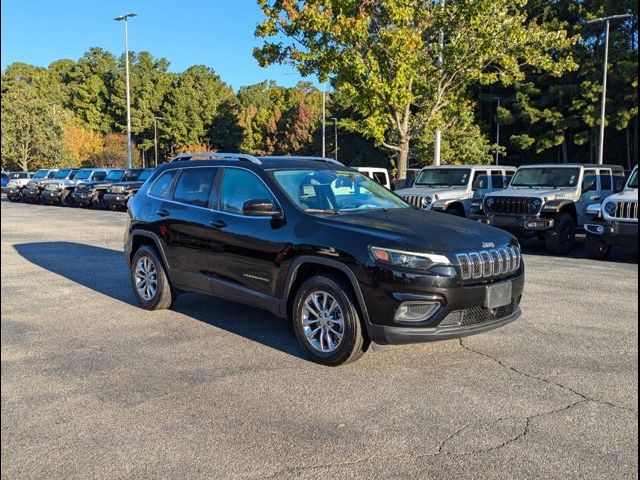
4;168;153;210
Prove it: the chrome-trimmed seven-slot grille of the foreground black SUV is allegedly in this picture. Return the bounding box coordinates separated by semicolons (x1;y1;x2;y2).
456;247;522;280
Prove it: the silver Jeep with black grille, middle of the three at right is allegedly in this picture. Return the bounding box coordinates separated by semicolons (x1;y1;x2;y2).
479;164;624;255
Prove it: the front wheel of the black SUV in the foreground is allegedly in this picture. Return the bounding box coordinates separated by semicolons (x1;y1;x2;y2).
292;274;370;367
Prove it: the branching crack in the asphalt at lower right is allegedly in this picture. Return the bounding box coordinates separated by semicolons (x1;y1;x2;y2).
249;338;637;479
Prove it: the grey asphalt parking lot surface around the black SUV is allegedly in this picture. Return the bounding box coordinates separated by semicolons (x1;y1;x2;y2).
1;199;638;479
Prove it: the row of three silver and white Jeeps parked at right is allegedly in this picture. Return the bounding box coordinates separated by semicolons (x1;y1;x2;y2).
396;164;638;258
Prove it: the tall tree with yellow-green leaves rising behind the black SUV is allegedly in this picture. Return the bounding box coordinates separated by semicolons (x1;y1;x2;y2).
254;0;573;178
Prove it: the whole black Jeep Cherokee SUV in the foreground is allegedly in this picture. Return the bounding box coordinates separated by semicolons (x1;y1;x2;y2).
125;154;524;365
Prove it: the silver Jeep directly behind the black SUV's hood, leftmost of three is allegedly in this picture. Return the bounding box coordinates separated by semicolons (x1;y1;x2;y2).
396;165;516;217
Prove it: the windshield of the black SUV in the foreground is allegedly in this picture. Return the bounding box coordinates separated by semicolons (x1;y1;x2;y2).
274;170;410;213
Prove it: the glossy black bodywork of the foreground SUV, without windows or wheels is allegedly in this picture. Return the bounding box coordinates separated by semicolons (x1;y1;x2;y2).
125;157;524;344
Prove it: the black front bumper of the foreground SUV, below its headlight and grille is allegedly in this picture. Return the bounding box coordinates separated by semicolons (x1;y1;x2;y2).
360;267;525;345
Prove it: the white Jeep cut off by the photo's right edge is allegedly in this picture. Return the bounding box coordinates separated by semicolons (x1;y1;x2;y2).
584;167;638;260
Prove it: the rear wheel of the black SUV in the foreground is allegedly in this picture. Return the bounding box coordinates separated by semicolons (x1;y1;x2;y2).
130;245;174;310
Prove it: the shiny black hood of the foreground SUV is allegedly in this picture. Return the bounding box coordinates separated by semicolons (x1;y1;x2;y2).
316;208;516;254
